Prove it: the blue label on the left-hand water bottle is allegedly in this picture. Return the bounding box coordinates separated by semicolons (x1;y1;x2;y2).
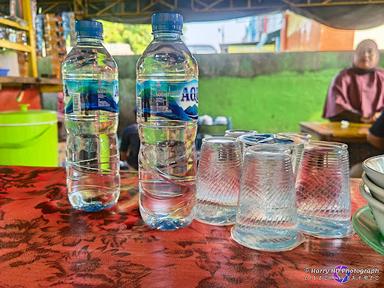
64;80;119;114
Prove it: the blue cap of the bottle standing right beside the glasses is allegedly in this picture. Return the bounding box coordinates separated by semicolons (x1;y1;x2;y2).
152;12;183;32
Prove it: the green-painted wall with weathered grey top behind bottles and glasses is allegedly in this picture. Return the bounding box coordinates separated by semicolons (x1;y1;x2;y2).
39;52;362;132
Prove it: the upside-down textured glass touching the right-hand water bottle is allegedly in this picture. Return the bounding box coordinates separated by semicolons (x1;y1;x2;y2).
195;137;242;225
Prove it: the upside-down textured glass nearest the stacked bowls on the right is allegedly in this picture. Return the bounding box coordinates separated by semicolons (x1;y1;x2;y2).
296;141;353;238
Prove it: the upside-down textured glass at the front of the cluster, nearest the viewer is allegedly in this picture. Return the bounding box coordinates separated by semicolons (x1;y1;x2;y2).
231;144;304;251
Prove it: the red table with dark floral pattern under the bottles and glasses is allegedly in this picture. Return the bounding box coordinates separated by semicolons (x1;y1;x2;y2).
0;167;384;288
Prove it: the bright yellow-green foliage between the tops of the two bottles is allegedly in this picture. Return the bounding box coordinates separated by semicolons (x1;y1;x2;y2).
101;21;152;54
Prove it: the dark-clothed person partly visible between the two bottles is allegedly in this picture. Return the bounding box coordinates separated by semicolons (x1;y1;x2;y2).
120;123;140;170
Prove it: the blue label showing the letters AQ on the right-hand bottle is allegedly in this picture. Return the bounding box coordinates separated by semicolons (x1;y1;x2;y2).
136;80;199;121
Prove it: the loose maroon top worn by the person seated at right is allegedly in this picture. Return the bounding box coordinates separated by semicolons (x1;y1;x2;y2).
323;67;384;118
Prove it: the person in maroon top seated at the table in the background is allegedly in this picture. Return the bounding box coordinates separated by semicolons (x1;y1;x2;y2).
323;40;384;123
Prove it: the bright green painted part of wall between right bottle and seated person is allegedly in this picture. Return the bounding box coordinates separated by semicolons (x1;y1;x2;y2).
199;69;339;132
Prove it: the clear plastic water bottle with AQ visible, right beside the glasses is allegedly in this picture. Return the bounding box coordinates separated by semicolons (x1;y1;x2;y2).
136;13;198;230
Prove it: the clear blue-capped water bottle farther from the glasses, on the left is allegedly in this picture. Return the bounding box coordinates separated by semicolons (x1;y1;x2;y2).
62;20;120;212
